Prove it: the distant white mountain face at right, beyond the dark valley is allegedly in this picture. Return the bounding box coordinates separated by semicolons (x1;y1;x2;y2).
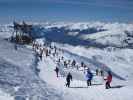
81;23;133;47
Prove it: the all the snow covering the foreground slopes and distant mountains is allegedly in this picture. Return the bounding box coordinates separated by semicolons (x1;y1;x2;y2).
0;22;133;100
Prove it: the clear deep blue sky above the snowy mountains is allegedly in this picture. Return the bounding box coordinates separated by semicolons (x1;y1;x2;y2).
0;0;133;22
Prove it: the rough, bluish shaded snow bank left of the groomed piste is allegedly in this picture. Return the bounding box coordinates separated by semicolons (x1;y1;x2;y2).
0;38;62;100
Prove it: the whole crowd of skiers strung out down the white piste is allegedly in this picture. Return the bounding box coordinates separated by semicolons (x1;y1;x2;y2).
33;43;112;89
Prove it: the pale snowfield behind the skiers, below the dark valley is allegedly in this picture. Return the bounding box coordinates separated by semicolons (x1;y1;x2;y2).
54;44;133;78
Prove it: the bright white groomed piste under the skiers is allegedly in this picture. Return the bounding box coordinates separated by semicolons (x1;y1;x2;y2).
38;43;133;100
